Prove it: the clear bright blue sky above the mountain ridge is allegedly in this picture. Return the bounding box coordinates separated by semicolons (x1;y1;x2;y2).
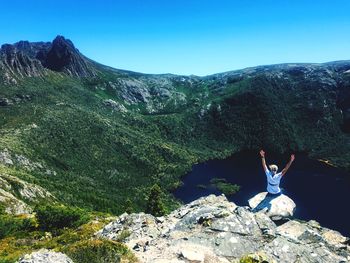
0;0;350;75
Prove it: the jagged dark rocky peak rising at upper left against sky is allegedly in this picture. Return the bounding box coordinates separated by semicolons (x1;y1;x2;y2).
0;36;97;81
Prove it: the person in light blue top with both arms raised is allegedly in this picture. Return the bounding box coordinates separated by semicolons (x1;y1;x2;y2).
260;150;295;196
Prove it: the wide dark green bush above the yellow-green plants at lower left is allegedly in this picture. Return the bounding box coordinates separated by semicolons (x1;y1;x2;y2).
35;205;89;231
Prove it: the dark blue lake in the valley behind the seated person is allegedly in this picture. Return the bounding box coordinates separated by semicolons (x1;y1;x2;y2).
174;153;350;236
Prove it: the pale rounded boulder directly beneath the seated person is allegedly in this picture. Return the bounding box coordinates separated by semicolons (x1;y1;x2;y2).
248;192;296;220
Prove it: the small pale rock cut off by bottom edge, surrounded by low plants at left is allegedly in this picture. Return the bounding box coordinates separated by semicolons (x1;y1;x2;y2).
17;249;73;263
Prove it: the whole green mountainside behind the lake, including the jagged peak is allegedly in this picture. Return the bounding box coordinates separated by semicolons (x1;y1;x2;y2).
0;36;350;217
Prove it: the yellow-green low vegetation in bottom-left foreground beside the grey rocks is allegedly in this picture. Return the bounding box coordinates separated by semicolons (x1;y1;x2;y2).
0;214;137;263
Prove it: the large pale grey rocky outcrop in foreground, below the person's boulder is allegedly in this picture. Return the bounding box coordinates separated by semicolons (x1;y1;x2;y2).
96;195;350;263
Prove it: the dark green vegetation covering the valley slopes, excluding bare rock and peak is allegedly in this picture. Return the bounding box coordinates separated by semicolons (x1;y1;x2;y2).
0;68;350;219
